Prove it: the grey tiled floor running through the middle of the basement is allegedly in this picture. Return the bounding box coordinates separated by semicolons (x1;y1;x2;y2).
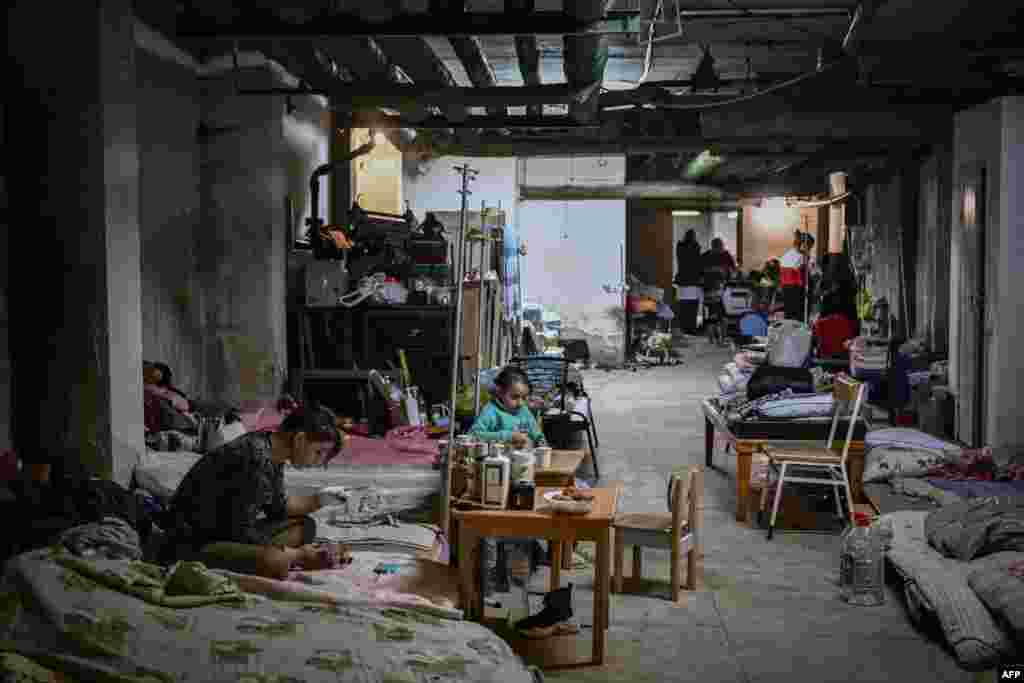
520;341;990;683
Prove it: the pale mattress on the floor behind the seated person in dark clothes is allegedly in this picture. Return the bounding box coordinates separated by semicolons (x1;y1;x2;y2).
133;451;441;513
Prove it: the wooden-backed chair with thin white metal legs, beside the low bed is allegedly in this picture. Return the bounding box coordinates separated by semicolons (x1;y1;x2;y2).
761;375;867;540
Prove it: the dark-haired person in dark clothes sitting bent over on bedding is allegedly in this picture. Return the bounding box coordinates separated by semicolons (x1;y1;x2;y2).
164;405;346;579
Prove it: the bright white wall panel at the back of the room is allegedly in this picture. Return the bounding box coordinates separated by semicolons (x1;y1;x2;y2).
519;200;626;332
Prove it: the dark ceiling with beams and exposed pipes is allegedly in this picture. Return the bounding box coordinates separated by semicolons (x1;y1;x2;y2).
157;0;1024;197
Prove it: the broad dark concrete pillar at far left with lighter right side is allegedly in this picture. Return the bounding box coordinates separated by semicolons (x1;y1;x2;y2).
5;0;144;483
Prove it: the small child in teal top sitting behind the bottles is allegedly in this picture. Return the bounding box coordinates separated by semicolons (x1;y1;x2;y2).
470;366;546;449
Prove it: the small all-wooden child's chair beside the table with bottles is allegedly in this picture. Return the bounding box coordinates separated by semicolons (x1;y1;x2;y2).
612;465;705;602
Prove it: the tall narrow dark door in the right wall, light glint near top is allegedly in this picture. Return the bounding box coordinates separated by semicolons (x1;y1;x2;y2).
956;164;987;446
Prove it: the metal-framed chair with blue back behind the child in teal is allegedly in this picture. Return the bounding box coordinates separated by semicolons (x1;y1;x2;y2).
508;355;601;479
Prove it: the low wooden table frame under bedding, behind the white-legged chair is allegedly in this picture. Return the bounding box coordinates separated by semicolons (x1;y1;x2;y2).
700;400;870;522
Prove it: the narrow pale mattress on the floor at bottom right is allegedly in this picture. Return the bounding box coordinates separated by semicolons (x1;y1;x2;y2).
885;510;1016;671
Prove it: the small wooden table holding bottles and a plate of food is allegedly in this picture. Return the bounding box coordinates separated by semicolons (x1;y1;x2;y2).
452;485;622;665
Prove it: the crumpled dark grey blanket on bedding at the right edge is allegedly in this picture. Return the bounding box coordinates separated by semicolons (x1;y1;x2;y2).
925;496;1024;561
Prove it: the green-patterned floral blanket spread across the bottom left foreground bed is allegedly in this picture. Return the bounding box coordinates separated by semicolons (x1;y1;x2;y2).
0;549;543;683
